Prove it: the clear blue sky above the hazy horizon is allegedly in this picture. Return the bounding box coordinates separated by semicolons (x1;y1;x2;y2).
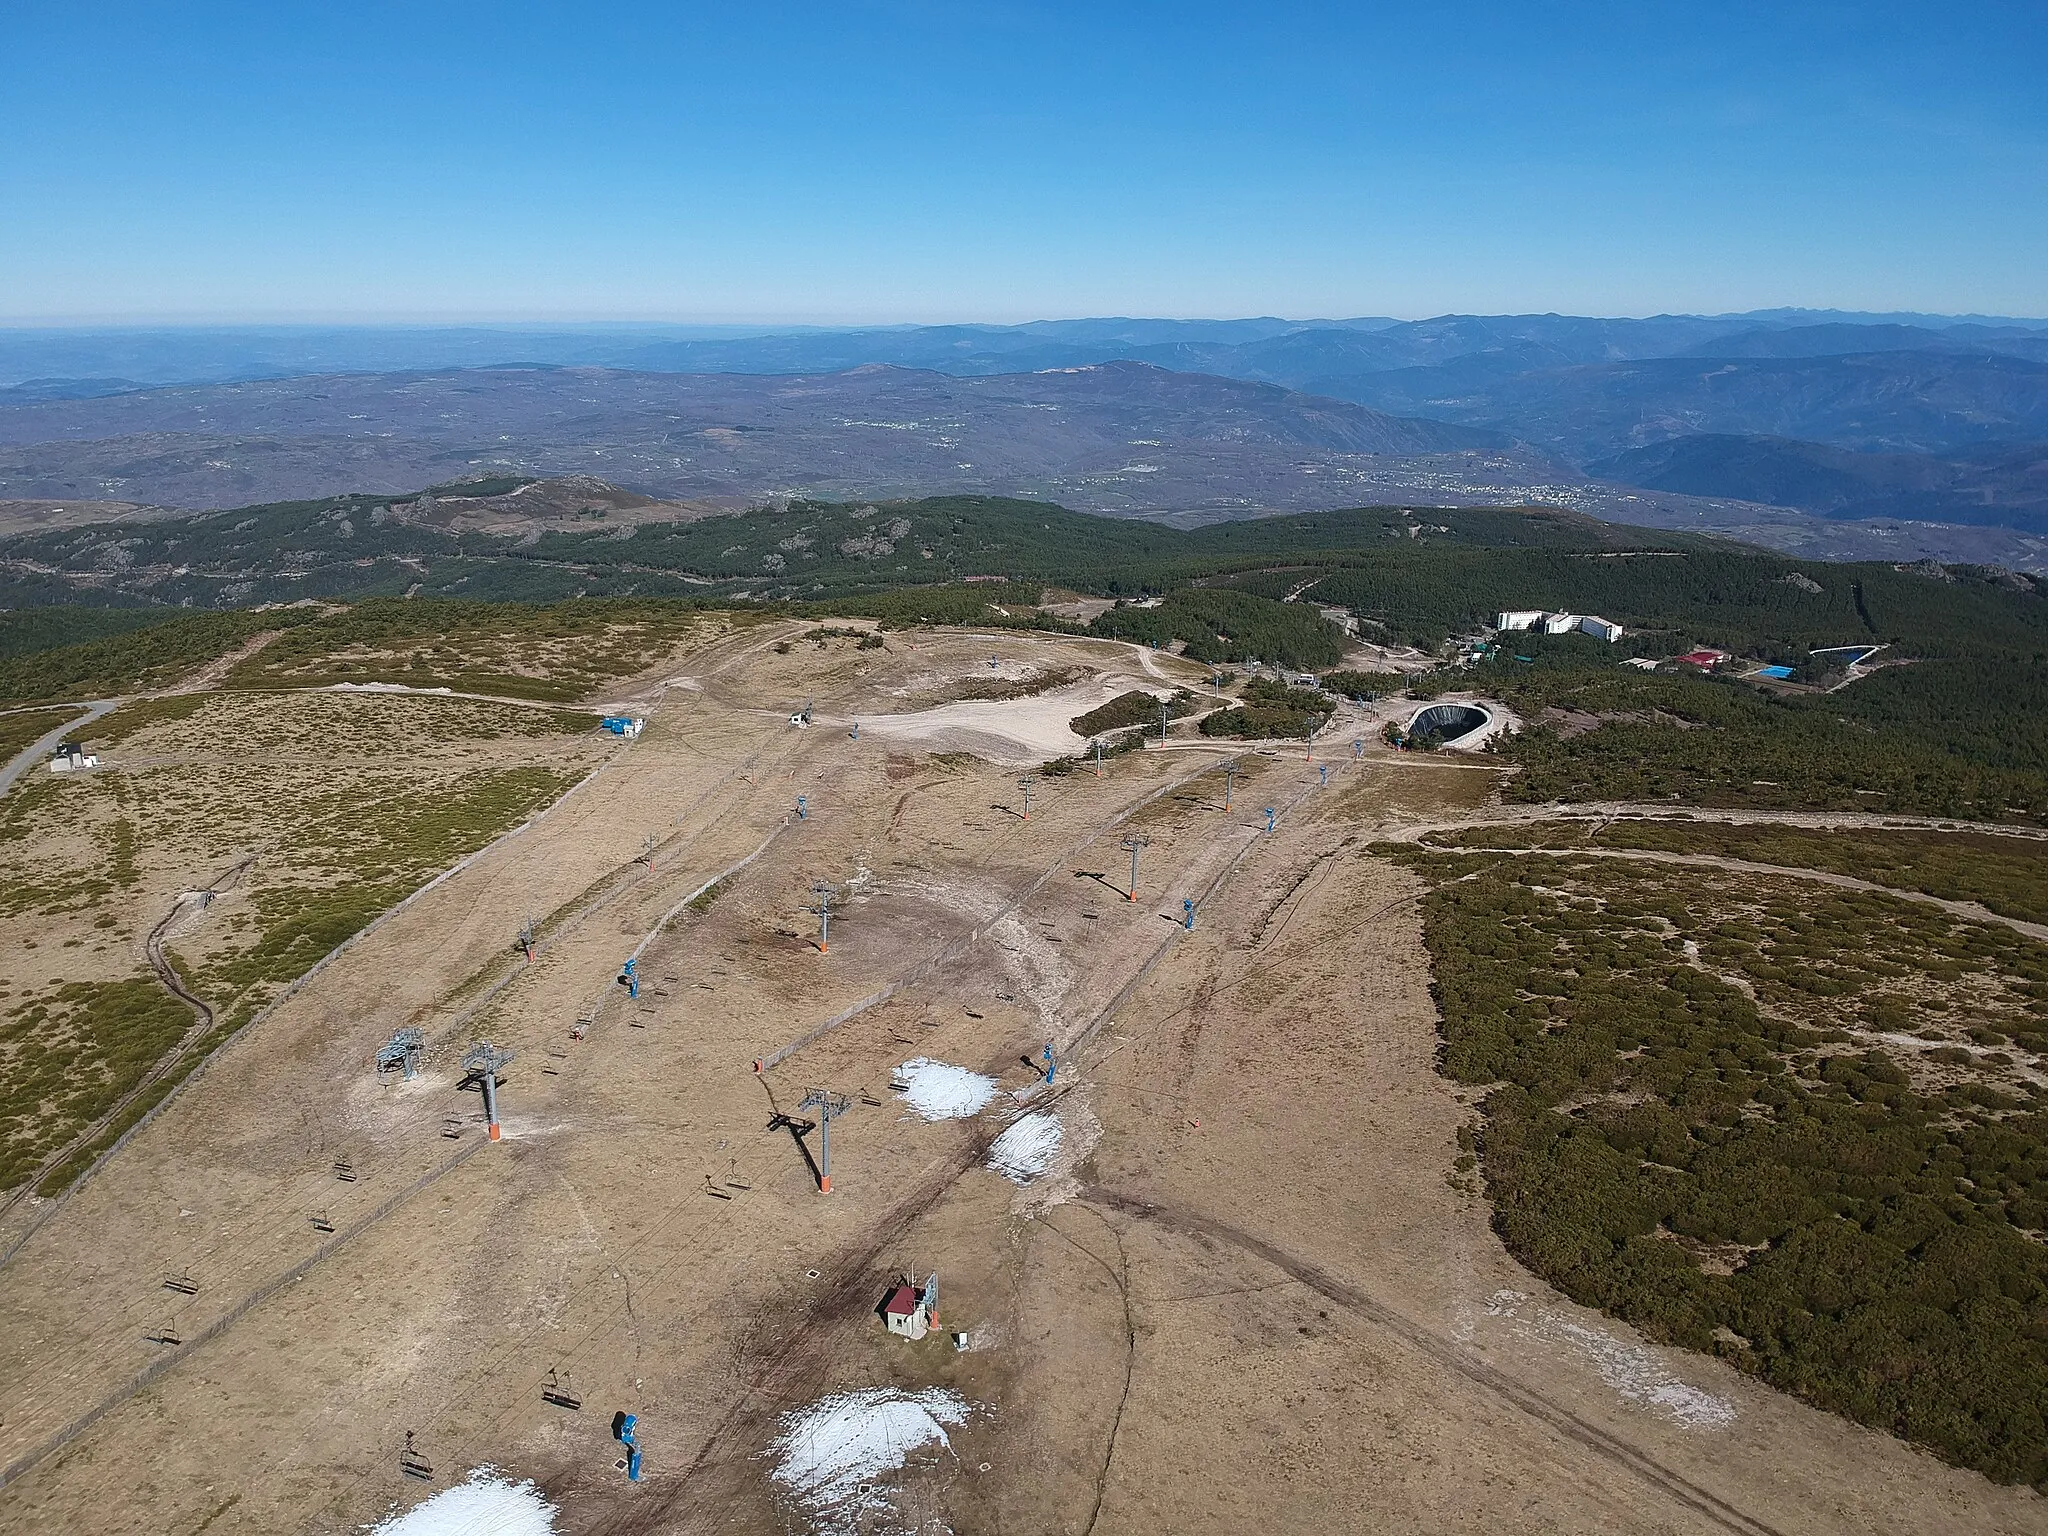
0;0;2048;324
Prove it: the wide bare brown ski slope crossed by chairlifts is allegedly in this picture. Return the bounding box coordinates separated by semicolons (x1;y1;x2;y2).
0;631;2048;1536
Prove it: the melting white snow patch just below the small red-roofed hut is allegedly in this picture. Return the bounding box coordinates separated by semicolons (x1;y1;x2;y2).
765;1386;969;1536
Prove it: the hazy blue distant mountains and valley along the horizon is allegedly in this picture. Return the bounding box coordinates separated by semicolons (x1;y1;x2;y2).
0;309;2048;561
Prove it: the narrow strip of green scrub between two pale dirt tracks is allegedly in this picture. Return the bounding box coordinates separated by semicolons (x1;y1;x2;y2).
1430;817;2048;924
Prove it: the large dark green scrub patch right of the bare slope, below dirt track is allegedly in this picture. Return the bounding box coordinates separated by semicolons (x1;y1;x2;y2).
1380;846;2048;1487
